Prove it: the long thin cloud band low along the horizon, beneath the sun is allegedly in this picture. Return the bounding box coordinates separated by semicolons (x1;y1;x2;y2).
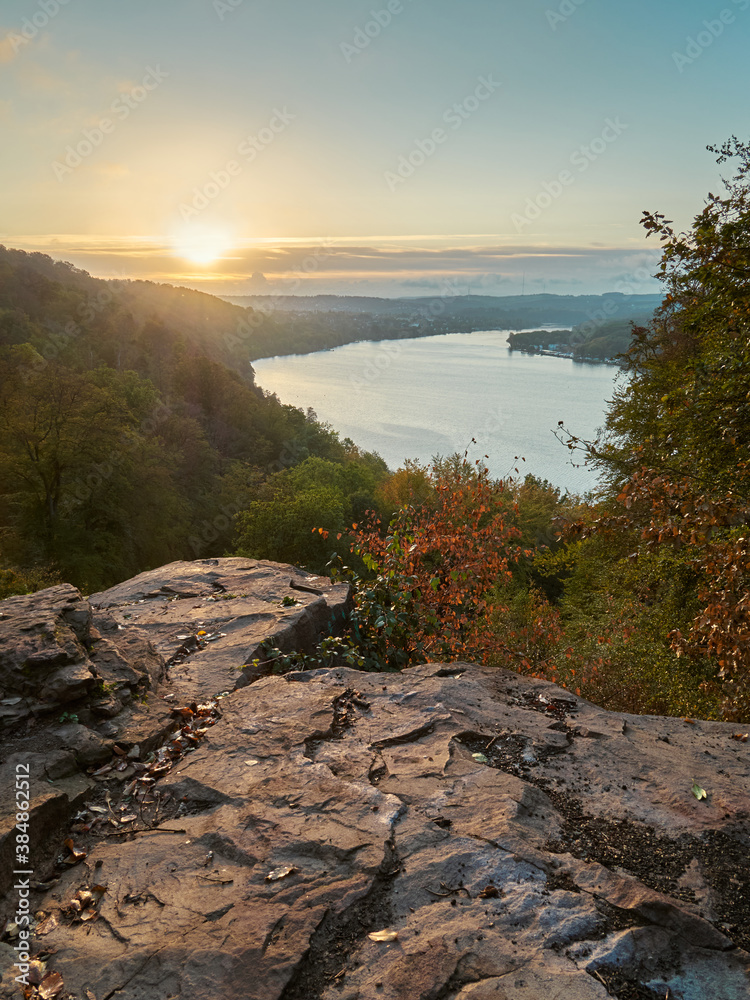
9;234;658;296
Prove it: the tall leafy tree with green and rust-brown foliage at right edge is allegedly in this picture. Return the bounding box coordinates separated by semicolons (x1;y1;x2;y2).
571;137;750;717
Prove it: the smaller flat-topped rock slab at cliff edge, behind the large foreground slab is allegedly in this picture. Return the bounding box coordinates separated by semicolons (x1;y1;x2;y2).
89;558;351;699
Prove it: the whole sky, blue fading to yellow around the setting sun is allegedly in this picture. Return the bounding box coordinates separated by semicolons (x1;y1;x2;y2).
0;0;750;296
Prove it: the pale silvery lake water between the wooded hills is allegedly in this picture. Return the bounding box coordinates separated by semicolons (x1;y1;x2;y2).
253;331;618;493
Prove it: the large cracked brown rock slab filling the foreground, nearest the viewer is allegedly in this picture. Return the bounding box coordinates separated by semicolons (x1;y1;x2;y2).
23;664;750;1000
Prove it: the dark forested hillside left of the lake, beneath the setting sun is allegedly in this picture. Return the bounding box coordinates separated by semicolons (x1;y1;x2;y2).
0;249;394;592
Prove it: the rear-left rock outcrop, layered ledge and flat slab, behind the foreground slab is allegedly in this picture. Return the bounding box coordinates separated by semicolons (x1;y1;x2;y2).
0;559;350;952
